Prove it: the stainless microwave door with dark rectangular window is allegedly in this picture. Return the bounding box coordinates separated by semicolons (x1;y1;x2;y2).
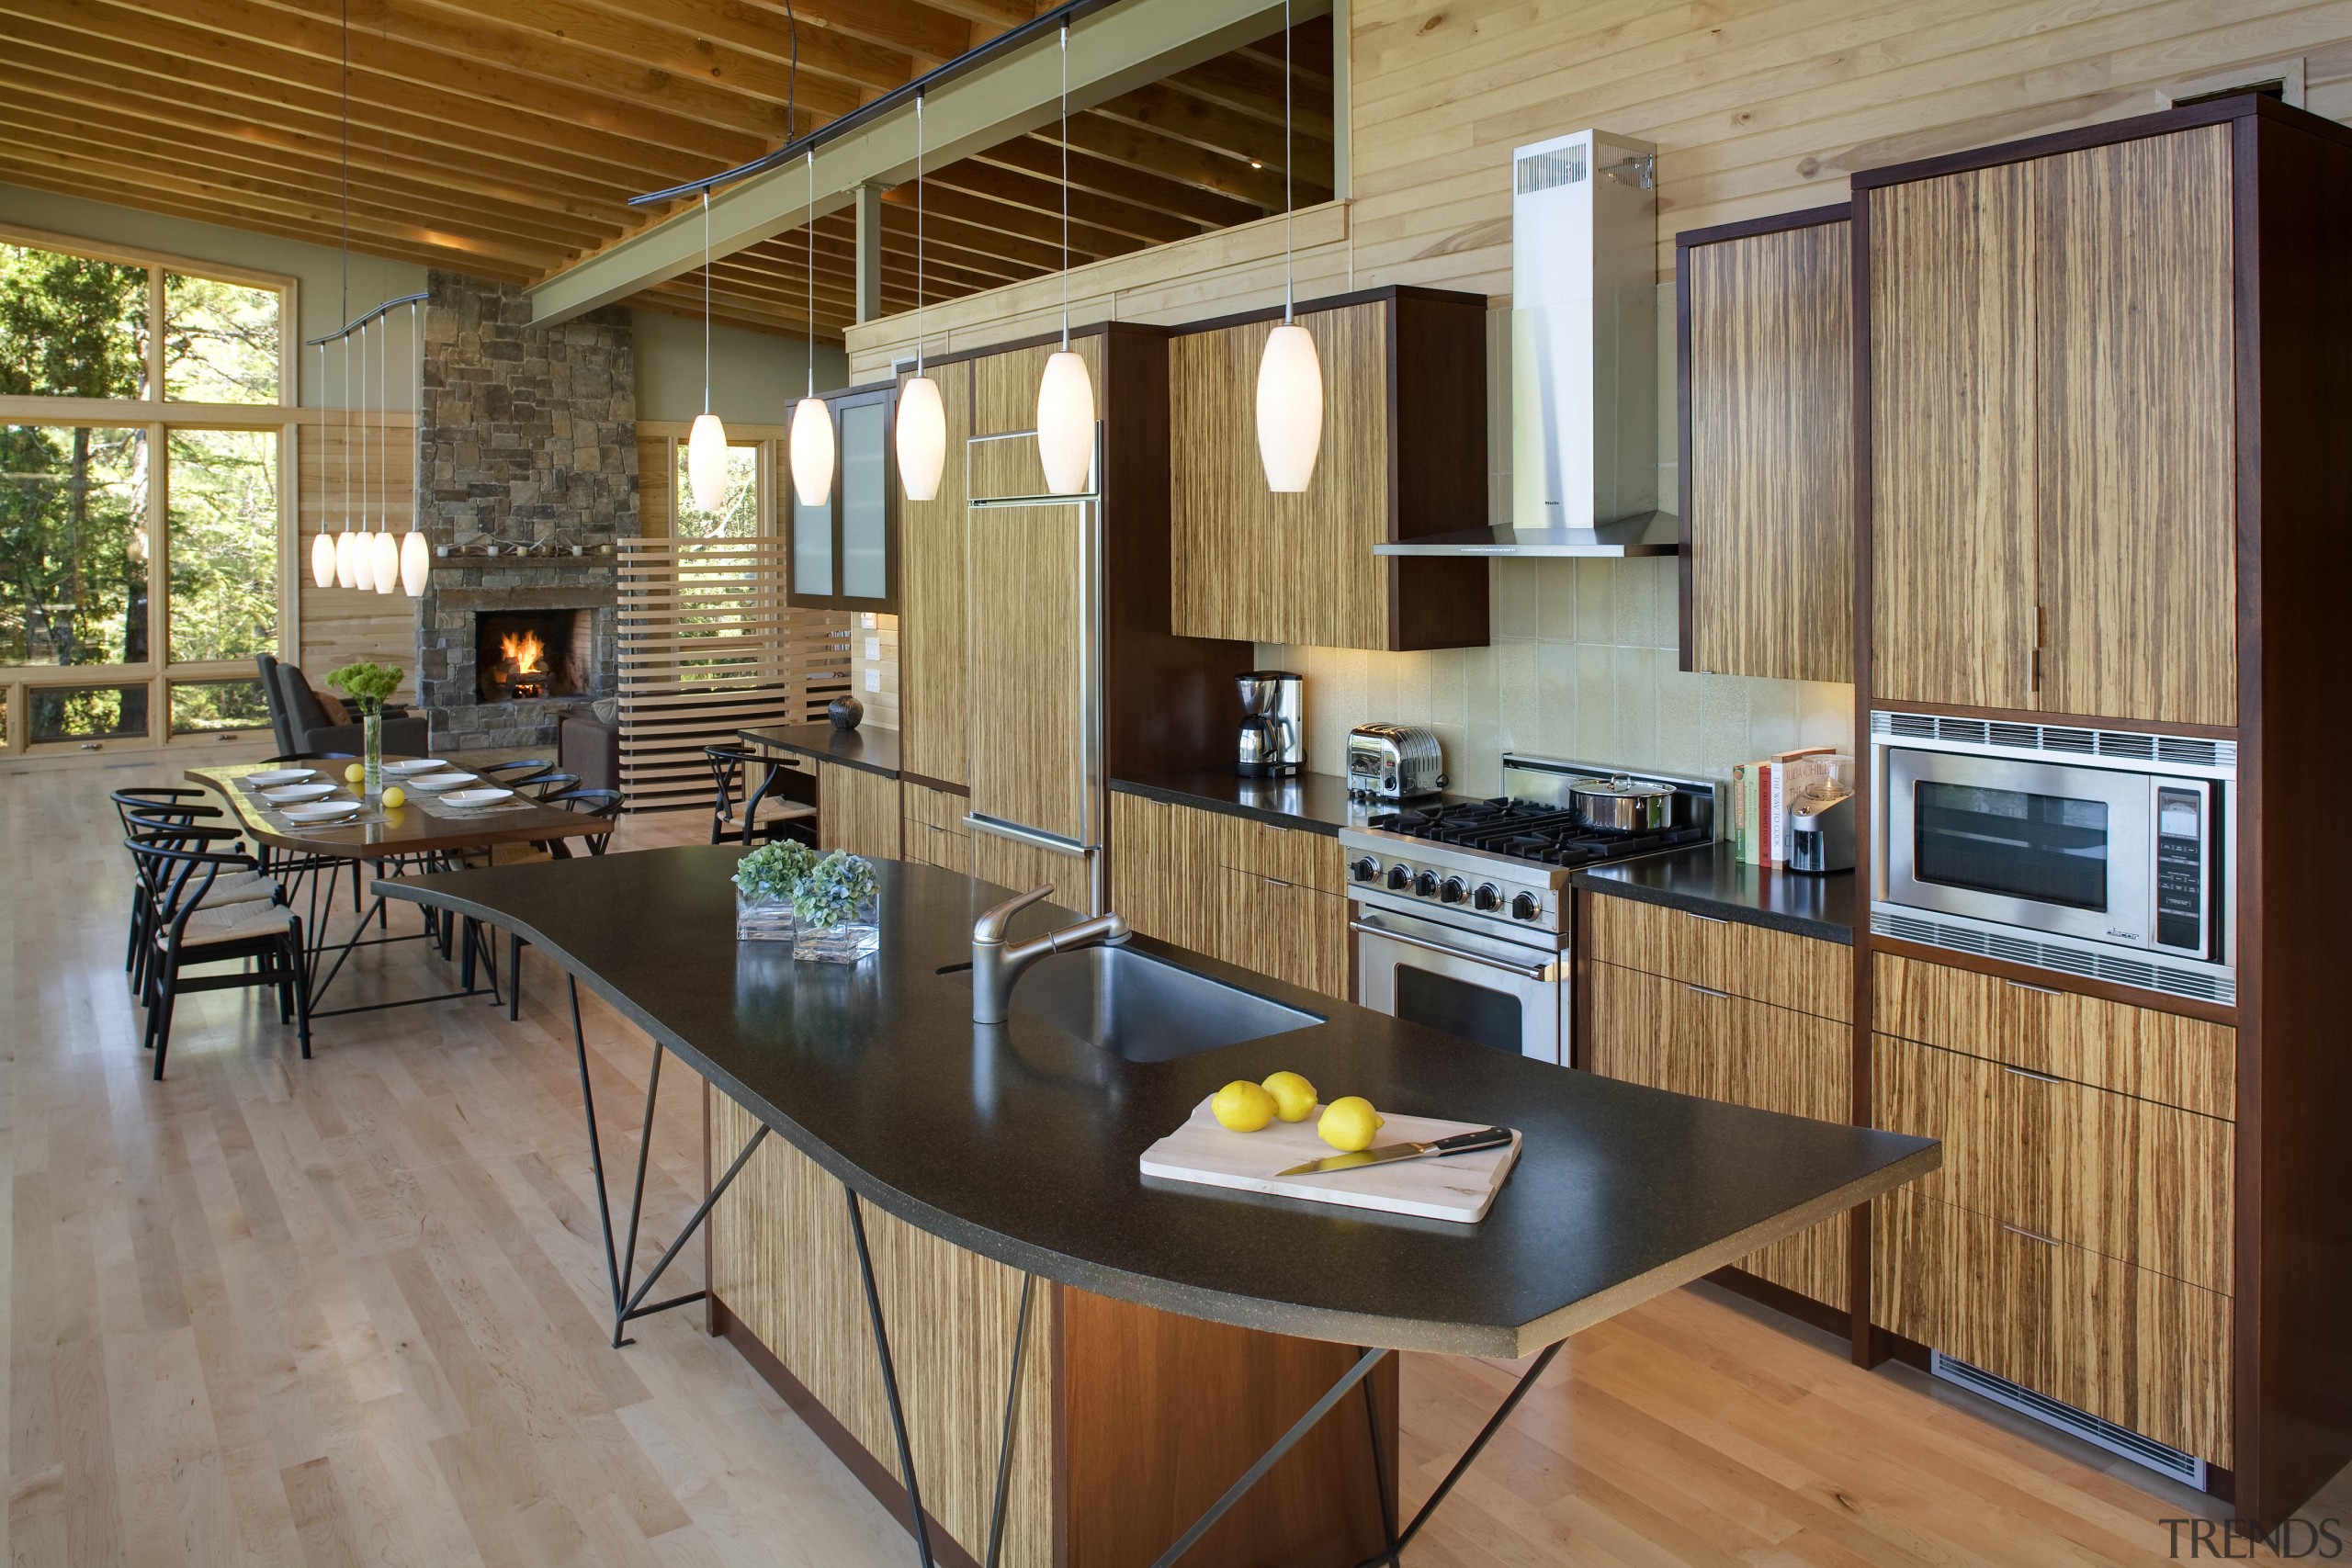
1879;748;2154;957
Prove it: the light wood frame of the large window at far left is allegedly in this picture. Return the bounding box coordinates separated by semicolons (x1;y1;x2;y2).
0;223;299;760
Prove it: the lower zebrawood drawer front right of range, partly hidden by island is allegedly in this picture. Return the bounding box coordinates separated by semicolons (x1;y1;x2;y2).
1592;964;1853;1307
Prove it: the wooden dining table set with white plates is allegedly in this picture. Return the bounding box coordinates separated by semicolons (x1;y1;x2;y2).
186;757;612;1018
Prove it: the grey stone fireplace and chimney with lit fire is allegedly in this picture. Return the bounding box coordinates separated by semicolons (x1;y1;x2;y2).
416;273;638;750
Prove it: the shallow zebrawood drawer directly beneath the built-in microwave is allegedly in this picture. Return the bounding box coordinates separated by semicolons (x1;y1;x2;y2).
1870;952;2237;1119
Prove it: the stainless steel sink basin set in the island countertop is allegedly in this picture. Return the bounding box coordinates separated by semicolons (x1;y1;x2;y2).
953;947;1322;1063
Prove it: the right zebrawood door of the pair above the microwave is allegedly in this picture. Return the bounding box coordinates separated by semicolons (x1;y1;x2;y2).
2034;125;2237;724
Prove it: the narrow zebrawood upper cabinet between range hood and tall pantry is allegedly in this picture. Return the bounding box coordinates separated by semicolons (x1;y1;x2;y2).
1675;207;1853;682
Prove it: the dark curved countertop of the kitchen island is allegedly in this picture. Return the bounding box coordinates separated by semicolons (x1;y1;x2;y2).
377;846;1940;1357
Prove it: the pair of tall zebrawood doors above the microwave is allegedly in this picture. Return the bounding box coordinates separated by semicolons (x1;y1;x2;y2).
1858;125;2237;727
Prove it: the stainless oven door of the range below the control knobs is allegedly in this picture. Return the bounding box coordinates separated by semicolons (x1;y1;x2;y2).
1350;905;1566;1063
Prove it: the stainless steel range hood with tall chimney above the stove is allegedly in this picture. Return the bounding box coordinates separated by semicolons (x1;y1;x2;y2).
1374;130;1681;558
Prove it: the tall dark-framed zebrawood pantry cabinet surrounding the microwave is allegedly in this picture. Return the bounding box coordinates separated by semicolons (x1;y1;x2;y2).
1853;94;2352;1521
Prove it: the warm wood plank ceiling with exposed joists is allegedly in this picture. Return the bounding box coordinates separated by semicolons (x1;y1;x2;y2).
0;0;1334;339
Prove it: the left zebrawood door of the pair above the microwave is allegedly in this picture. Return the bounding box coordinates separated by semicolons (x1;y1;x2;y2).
1868;163;2040;707
